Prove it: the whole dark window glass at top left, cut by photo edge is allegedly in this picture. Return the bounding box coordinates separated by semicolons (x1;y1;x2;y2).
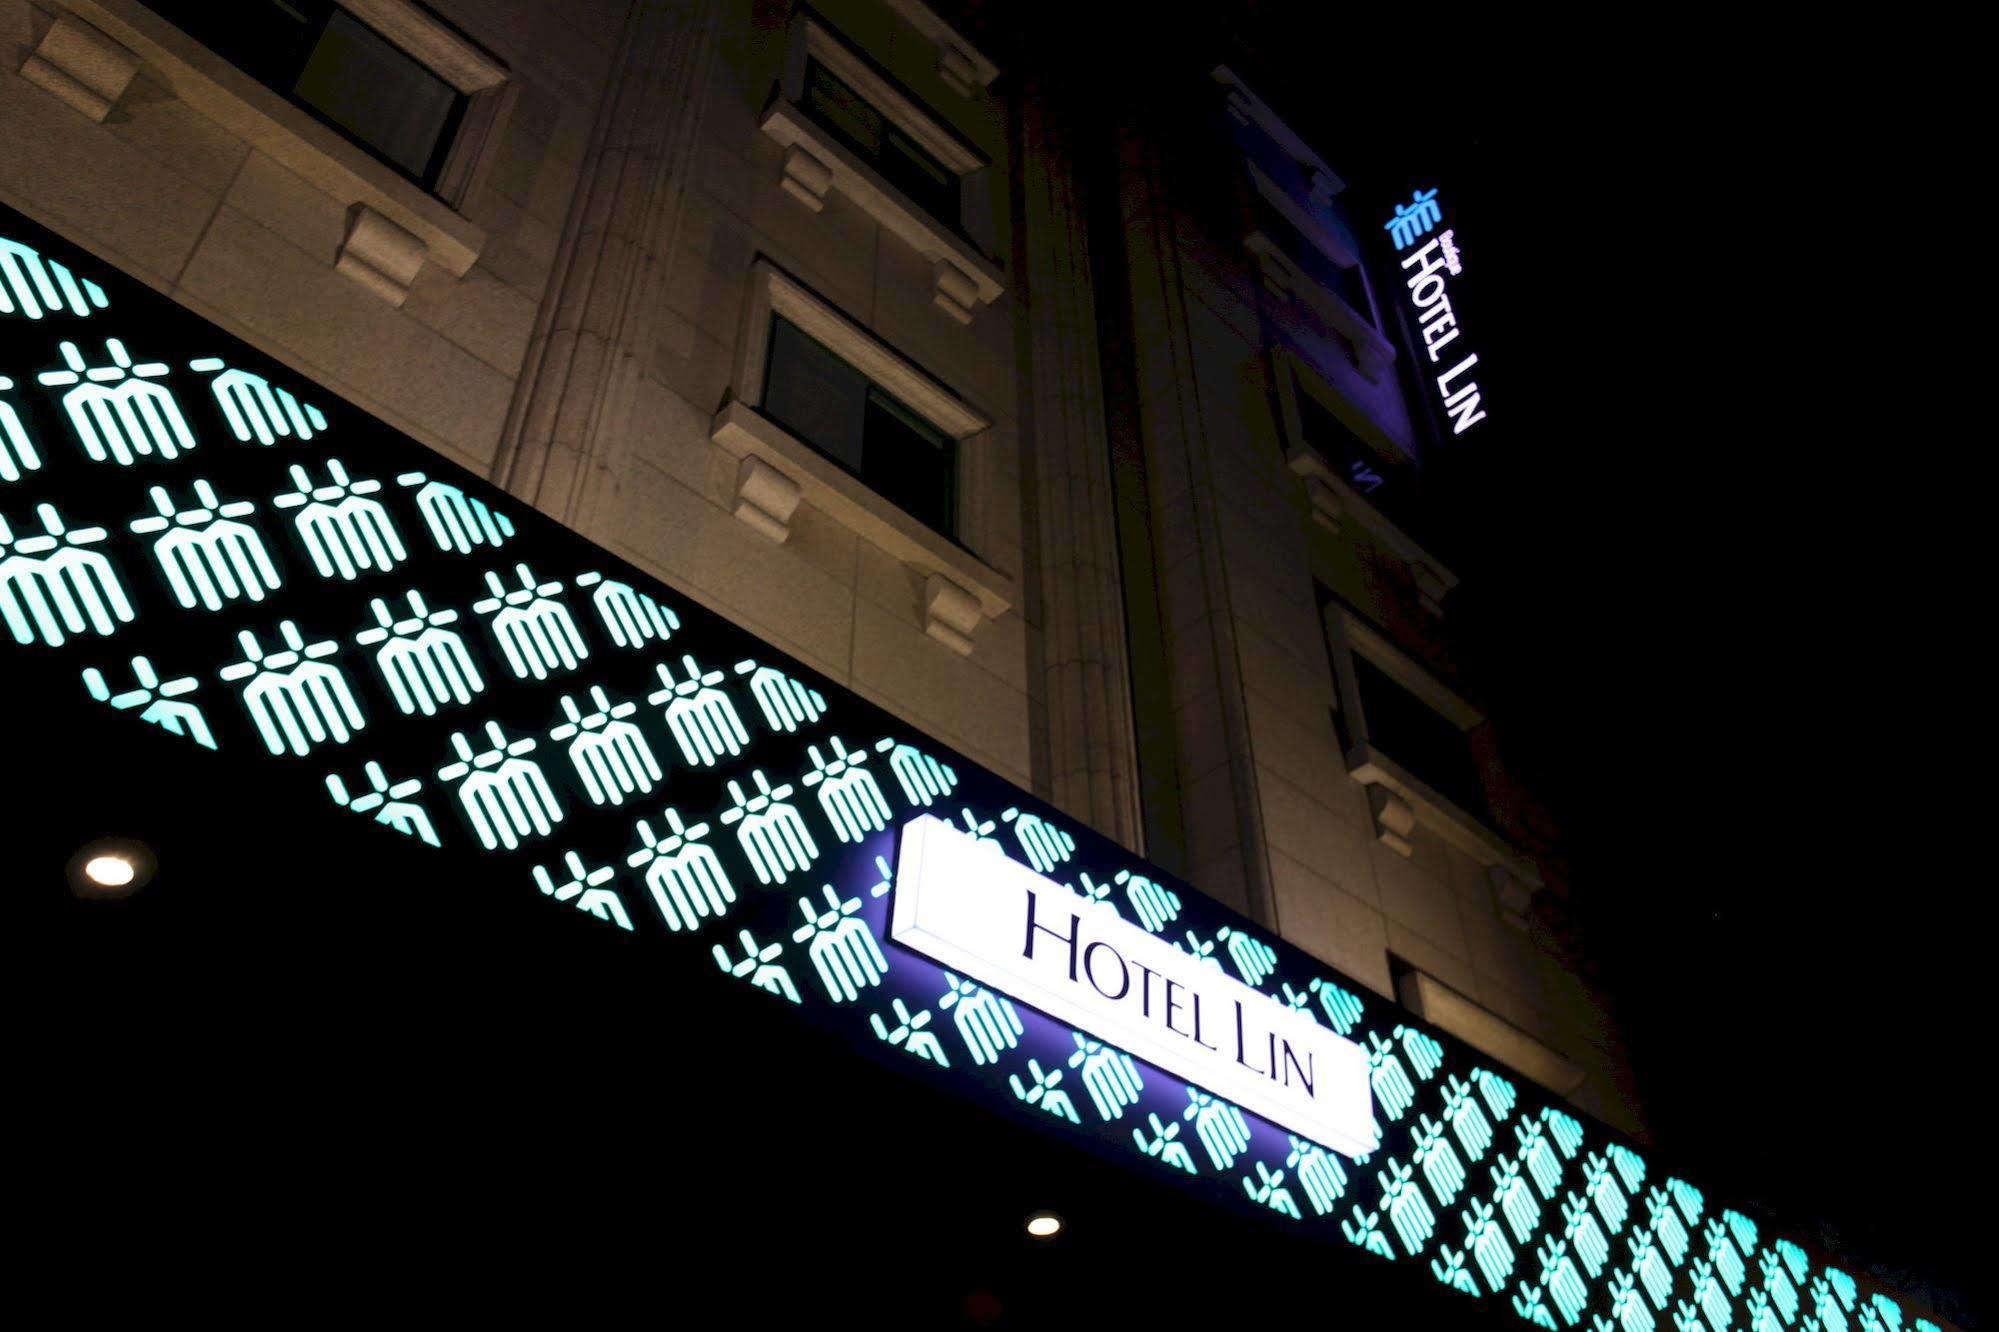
146;0;470;188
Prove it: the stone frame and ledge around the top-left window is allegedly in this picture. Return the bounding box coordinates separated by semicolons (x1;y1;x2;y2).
66;0;495;278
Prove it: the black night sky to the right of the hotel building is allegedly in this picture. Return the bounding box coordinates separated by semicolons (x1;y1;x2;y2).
987;0;1991;1326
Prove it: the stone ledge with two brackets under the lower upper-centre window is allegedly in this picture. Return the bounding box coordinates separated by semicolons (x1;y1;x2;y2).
710;400;1019;640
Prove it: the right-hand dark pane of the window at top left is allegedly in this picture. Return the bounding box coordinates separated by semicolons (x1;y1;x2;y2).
292;10;458;178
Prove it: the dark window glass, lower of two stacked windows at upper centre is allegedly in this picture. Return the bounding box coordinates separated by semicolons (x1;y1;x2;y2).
764;316;958;540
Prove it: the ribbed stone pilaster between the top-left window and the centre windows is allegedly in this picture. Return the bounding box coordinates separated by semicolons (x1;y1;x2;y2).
494;0;720;534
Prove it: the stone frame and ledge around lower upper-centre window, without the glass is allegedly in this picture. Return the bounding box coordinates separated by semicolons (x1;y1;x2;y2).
710;254;1019;620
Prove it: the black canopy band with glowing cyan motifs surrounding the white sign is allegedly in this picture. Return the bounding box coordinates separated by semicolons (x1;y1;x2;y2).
0;208;1931;1332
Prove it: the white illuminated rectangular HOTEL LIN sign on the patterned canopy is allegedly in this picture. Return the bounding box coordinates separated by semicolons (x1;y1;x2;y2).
890;814;1379;1156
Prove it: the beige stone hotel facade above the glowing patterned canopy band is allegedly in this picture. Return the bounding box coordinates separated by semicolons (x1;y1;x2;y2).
0;0;1639;1130
